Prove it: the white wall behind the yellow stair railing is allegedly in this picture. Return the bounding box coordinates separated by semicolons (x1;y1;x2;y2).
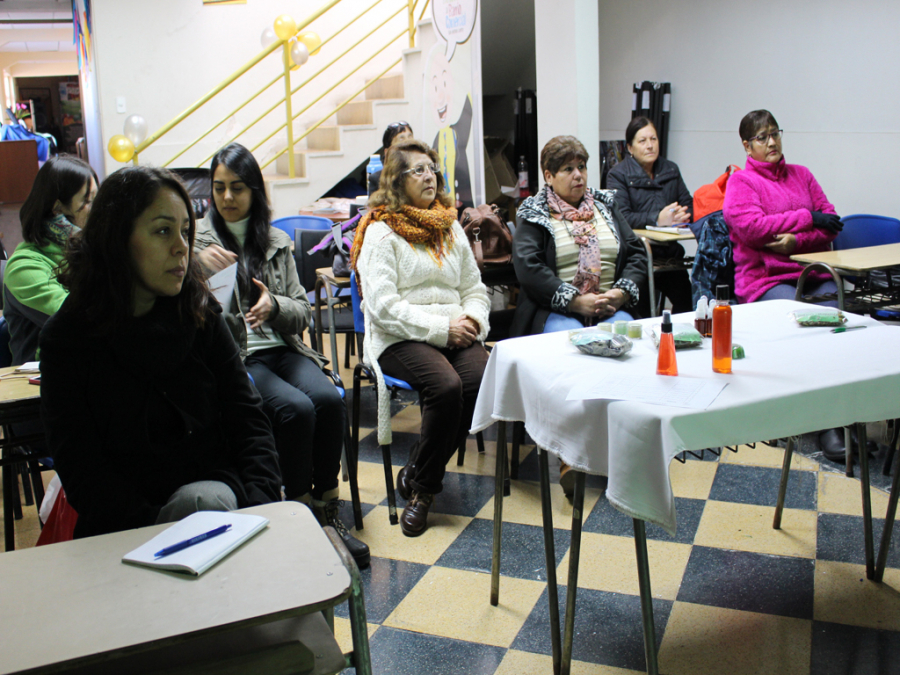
91;0;409;177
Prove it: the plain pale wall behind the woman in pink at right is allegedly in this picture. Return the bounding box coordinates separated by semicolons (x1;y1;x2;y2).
596;0;900;216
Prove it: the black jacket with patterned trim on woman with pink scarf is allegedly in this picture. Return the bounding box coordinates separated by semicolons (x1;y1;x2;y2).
510;189;647;337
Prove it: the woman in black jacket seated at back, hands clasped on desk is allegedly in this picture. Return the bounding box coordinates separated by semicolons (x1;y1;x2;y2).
606;117;694;316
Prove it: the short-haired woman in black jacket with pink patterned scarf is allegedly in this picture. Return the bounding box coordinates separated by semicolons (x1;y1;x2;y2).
510;136;647;336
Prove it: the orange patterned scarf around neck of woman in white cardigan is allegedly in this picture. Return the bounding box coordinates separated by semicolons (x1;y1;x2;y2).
350;200;456;296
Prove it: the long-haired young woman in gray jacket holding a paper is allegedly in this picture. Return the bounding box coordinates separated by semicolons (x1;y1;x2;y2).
195;143;369;567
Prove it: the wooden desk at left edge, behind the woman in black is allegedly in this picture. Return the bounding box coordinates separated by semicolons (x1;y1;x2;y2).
0;367;44;551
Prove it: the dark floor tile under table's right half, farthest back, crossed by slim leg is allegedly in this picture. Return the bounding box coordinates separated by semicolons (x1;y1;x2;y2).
709;464;817;511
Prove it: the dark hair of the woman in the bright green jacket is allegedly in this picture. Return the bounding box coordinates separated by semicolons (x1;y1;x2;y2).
19;155;100;246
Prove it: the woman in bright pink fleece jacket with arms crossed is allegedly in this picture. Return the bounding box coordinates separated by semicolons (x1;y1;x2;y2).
724;110;843;306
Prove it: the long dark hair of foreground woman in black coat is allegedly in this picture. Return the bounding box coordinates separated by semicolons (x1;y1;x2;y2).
59;166;211;335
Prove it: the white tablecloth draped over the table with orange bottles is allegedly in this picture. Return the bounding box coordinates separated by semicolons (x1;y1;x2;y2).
472;300;900;534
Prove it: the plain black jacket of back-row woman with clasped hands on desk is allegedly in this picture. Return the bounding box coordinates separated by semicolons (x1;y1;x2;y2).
606;156;694;230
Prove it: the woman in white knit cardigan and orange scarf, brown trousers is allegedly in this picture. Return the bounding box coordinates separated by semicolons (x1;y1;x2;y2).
351;140;490;537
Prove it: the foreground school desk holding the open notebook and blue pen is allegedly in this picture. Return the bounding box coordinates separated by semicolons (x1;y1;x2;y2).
0;502;371;674
